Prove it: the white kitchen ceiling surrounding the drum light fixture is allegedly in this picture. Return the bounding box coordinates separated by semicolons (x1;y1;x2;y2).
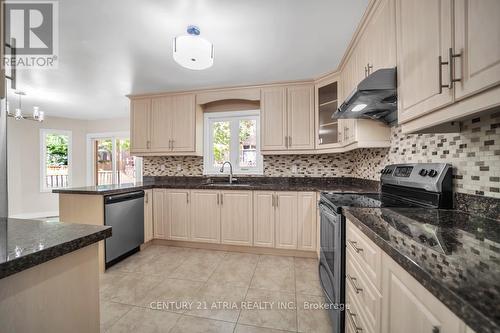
9;0;368;119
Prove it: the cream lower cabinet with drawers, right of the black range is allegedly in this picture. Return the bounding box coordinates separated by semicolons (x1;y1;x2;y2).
345;220;472;333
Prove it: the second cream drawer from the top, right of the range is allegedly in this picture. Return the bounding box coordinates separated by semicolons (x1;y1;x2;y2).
346;249;382;332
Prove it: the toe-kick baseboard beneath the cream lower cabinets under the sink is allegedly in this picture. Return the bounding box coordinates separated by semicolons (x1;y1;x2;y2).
148;239;318;258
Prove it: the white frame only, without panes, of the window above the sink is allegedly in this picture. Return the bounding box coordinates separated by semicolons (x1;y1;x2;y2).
203;110;264;175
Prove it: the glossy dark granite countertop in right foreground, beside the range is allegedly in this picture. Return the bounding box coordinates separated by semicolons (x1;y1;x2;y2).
344;208;500;332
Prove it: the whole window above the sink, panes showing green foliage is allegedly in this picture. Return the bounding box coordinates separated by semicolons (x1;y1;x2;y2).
204;111;262;174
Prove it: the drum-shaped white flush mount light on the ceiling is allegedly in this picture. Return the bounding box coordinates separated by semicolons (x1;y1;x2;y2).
173;25;214;70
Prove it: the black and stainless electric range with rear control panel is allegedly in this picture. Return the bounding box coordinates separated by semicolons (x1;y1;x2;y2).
319;163;453;332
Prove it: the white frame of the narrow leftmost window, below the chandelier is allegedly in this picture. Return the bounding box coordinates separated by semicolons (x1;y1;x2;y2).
40;128;73;193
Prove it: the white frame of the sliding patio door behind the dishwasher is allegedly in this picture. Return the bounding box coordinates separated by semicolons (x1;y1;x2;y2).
86;132;142;186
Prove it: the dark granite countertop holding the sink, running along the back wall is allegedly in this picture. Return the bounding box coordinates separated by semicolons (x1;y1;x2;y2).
52;177;378;195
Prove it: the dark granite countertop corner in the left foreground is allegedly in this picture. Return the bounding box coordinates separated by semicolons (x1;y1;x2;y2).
0;218;111;279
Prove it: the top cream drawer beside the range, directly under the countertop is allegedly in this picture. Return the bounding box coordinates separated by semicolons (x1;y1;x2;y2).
346;220;382;290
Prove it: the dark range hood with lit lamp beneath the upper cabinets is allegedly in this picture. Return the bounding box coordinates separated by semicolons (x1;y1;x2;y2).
332;68;398;125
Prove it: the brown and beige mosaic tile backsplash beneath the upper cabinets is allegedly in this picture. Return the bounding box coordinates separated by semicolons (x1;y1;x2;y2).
143;112;500;198
